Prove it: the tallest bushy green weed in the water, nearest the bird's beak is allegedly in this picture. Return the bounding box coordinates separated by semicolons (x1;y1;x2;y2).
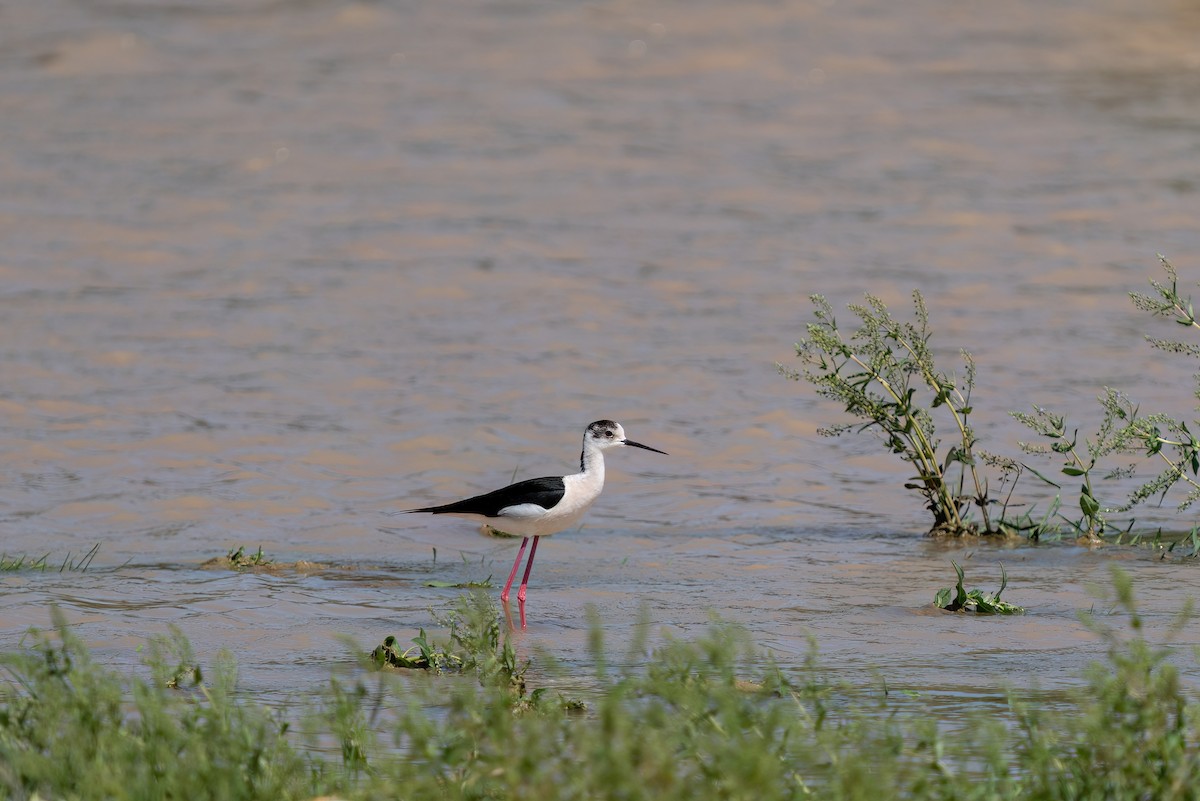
779;291;1004;535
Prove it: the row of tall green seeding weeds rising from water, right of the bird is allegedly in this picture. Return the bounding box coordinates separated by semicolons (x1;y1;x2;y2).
779;259;1200;544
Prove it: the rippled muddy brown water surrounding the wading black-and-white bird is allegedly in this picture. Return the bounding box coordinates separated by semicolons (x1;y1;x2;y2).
0;0;1200;709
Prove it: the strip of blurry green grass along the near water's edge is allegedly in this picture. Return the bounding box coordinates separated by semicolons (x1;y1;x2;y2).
0;572;1200;801
